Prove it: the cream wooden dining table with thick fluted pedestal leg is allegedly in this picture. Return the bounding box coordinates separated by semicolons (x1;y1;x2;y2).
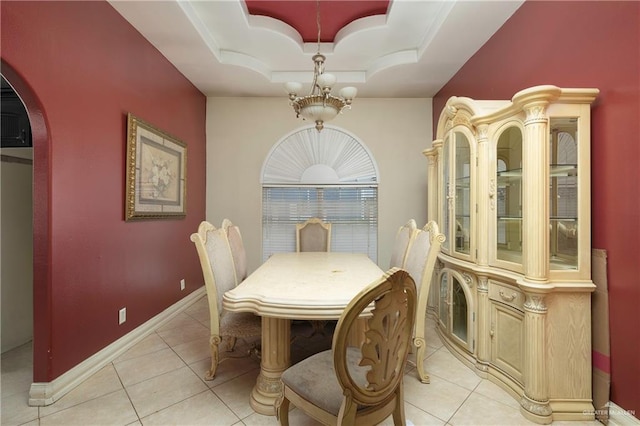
222;252;384;415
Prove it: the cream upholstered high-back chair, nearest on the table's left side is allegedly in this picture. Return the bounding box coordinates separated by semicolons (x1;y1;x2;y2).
191;221;262;380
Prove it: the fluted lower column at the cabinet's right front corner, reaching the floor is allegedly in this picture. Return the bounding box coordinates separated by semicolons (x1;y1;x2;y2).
520;292;551;423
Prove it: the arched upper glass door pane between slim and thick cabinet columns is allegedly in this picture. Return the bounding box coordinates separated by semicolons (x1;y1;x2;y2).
494;126;522;264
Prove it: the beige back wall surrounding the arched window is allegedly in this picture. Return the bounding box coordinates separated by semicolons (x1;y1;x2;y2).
206;96;432;271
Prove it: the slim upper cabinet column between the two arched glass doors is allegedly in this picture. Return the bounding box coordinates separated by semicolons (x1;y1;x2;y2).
476;124;490;266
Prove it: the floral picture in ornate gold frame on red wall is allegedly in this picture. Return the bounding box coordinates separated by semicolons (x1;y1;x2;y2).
125;113;187;221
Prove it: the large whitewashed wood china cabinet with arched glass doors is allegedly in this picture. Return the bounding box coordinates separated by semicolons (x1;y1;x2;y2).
424;85;598;424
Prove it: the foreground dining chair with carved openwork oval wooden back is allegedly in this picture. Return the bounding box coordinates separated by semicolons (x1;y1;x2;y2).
276;268;417;425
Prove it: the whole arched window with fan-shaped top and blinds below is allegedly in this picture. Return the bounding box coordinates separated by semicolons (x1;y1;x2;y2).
261;126;379;262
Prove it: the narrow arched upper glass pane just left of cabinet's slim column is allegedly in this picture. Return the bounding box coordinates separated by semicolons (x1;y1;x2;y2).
454;132;471;255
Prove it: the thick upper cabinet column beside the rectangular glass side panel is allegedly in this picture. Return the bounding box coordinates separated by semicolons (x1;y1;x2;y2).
522;99;549;282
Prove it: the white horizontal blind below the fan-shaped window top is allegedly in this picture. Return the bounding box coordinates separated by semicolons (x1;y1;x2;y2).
262;185;378;262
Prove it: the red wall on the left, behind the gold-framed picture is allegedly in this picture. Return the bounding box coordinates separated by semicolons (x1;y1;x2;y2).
1;1;206;382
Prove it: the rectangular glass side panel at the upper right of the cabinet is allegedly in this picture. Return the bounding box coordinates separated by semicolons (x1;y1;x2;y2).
549;117;579;269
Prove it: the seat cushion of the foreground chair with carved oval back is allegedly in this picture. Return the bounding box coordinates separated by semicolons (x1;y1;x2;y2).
282;347;370;416
